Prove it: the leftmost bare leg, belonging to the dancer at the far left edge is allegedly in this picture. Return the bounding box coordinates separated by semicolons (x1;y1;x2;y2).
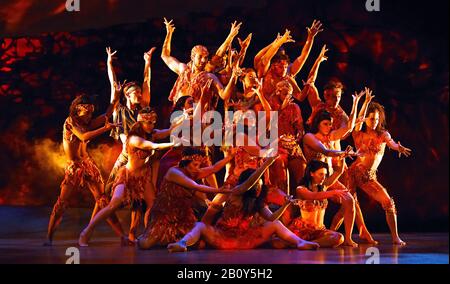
44;184;74;246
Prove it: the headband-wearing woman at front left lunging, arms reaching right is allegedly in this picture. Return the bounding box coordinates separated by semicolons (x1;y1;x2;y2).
78;108;179;246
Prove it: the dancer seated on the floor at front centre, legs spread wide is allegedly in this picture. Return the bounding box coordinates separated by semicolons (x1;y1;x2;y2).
167;166;319;252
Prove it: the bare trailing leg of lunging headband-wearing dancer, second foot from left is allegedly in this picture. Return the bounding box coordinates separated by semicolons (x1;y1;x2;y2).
78;184;126;246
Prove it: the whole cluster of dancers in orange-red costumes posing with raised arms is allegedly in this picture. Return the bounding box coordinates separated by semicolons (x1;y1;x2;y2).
45;19;411;252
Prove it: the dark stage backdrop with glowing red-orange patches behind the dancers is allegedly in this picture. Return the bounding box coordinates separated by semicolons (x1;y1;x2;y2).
0;0;449;231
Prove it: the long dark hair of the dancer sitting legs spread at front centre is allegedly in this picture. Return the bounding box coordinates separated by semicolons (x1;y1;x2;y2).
238;169;267;216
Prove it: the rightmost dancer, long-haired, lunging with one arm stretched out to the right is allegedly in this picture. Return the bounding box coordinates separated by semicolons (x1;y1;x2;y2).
337;99;411;246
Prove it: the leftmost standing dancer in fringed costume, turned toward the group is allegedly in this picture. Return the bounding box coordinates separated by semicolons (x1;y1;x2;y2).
44;94;123;246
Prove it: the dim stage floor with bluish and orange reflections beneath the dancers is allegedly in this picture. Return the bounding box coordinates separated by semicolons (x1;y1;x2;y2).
0;207;449;264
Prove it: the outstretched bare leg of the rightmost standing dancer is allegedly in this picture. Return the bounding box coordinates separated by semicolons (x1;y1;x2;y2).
361;180;406;246
